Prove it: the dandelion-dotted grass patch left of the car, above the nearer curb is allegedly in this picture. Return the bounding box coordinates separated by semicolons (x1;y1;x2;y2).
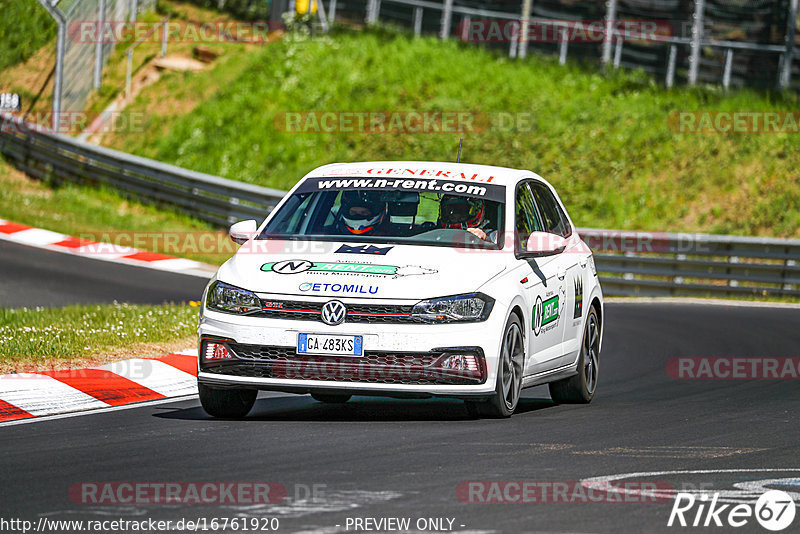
0;304;198;372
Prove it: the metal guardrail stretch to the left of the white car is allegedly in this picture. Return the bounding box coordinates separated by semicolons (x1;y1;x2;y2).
0;114;285;227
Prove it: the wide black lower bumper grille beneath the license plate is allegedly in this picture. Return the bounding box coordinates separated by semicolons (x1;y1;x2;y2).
203;343;485;385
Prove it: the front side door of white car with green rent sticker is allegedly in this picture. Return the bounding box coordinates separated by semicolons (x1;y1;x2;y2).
514;181;566;375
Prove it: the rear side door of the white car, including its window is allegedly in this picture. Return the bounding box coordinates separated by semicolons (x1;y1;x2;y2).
530;182;588;367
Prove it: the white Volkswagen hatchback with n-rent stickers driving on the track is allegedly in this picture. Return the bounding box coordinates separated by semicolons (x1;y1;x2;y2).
197;161;603;418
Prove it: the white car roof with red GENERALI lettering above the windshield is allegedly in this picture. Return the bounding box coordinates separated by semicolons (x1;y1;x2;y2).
306;161;535;185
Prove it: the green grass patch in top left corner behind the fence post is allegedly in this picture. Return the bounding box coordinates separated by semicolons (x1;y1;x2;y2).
0;0;56;71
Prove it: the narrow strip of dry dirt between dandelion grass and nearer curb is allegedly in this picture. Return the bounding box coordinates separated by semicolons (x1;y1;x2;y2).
0;336;197;374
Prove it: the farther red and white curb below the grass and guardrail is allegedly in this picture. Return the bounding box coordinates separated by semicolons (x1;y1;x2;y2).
0;219;216;278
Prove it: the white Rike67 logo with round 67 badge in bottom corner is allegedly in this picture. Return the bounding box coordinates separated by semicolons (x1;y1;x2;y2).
667;490;796;532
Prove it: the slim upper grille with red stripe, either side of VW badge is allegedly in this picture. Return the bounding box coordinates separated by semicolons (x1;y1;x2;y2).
257;300;420;324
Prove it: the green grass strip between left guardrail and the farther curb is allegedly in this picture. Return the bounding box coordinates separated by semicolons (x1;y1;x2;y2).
0;158;230;264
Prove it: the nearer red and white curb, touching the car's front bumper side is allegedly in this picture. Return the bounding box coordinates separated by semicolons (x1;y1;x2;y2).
0;350;197;421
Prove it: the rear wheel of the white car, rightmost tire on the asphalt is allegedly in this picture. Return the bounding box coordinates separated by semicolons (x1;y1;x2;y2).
550;307;600;404
